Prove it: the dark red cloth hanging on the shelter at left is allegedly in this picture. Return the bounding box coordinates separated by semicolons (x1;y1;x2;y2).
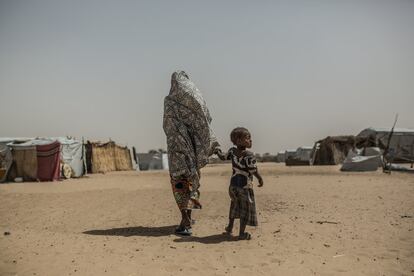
36;141;60;181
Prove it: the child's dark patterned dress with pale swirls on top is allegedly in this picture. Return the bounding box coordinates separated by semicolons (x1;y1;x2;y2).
226;147;258;226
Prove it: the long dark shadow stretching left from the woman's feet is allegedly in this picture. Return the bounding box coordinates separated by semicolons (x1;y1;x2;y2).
83;225;177;237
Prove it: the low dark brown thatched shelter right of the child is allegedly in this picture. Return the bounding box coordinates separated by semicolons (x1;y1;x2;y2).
311;135;369;165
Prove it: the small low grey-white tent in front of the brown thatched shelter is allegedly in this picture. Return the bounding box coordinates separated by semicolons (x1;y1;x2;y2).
341;147;382;172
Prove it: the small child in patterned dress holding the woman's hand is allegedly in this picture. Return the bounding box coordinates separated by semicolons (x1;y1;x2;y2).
215;127;263;240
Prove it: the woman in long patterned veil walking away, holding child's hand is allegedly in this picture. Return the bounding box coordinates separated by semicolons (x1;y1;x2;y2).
163;71;219;235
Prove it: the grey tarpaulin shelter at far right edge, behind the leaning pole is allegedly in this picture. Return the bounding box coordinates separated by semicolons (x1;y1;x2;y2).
357;128;414;163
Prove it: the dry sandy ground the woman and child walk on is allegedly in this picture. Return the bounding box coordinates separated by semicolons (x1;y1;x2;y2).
0;164;414;275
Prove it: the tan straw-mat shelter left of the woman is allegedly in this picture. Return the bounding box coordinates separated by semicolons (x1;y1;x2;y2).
85;141;132;173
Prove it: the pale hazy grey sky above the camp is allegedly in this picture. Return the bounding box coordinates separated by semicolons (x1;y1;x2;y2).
0;0;414;153
